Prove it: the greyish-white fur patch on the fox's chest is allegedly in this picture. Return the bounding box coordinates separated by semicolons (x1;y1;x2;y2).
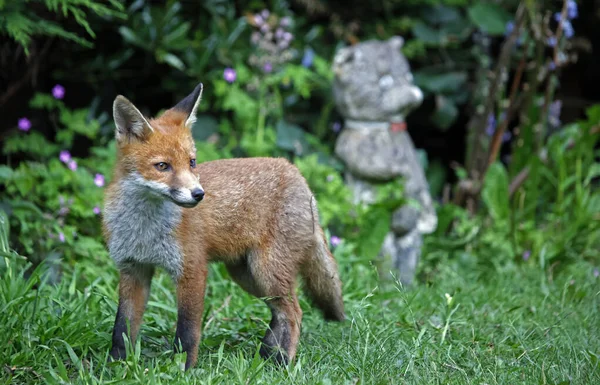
104;180;183;278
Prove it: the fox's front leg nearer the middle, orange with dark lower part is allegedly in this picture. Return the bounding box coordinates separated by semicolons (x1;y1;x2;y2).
174;265;208;370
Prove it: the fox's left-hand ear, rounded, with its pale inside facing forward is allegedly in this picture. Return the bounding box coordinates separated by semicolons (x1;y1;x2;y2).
113;95;153;142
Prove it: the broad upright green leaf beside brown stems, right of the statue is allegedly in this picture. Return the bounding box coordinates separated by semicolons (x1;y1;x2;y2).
481;162;510;222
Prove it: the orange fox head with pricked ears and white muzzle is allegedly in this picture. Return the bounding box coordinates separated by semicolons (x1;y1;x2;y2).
113;83;204;207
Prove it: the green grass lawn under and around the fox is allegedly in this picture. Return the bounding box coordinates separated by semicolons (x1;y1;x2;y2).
0;244;600;384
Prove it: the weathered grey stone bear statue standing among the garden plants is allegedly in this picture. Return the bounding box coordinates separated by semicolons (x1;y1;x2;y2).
333;36;437;285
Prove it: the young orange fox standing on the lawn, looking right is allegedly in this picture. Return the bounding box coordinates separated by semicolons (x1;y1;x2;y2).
102;83;346;371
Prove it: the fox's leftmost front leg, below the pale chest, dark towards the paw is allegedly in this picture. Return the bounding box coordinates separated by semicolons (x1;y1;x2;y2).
110;267;154;359
